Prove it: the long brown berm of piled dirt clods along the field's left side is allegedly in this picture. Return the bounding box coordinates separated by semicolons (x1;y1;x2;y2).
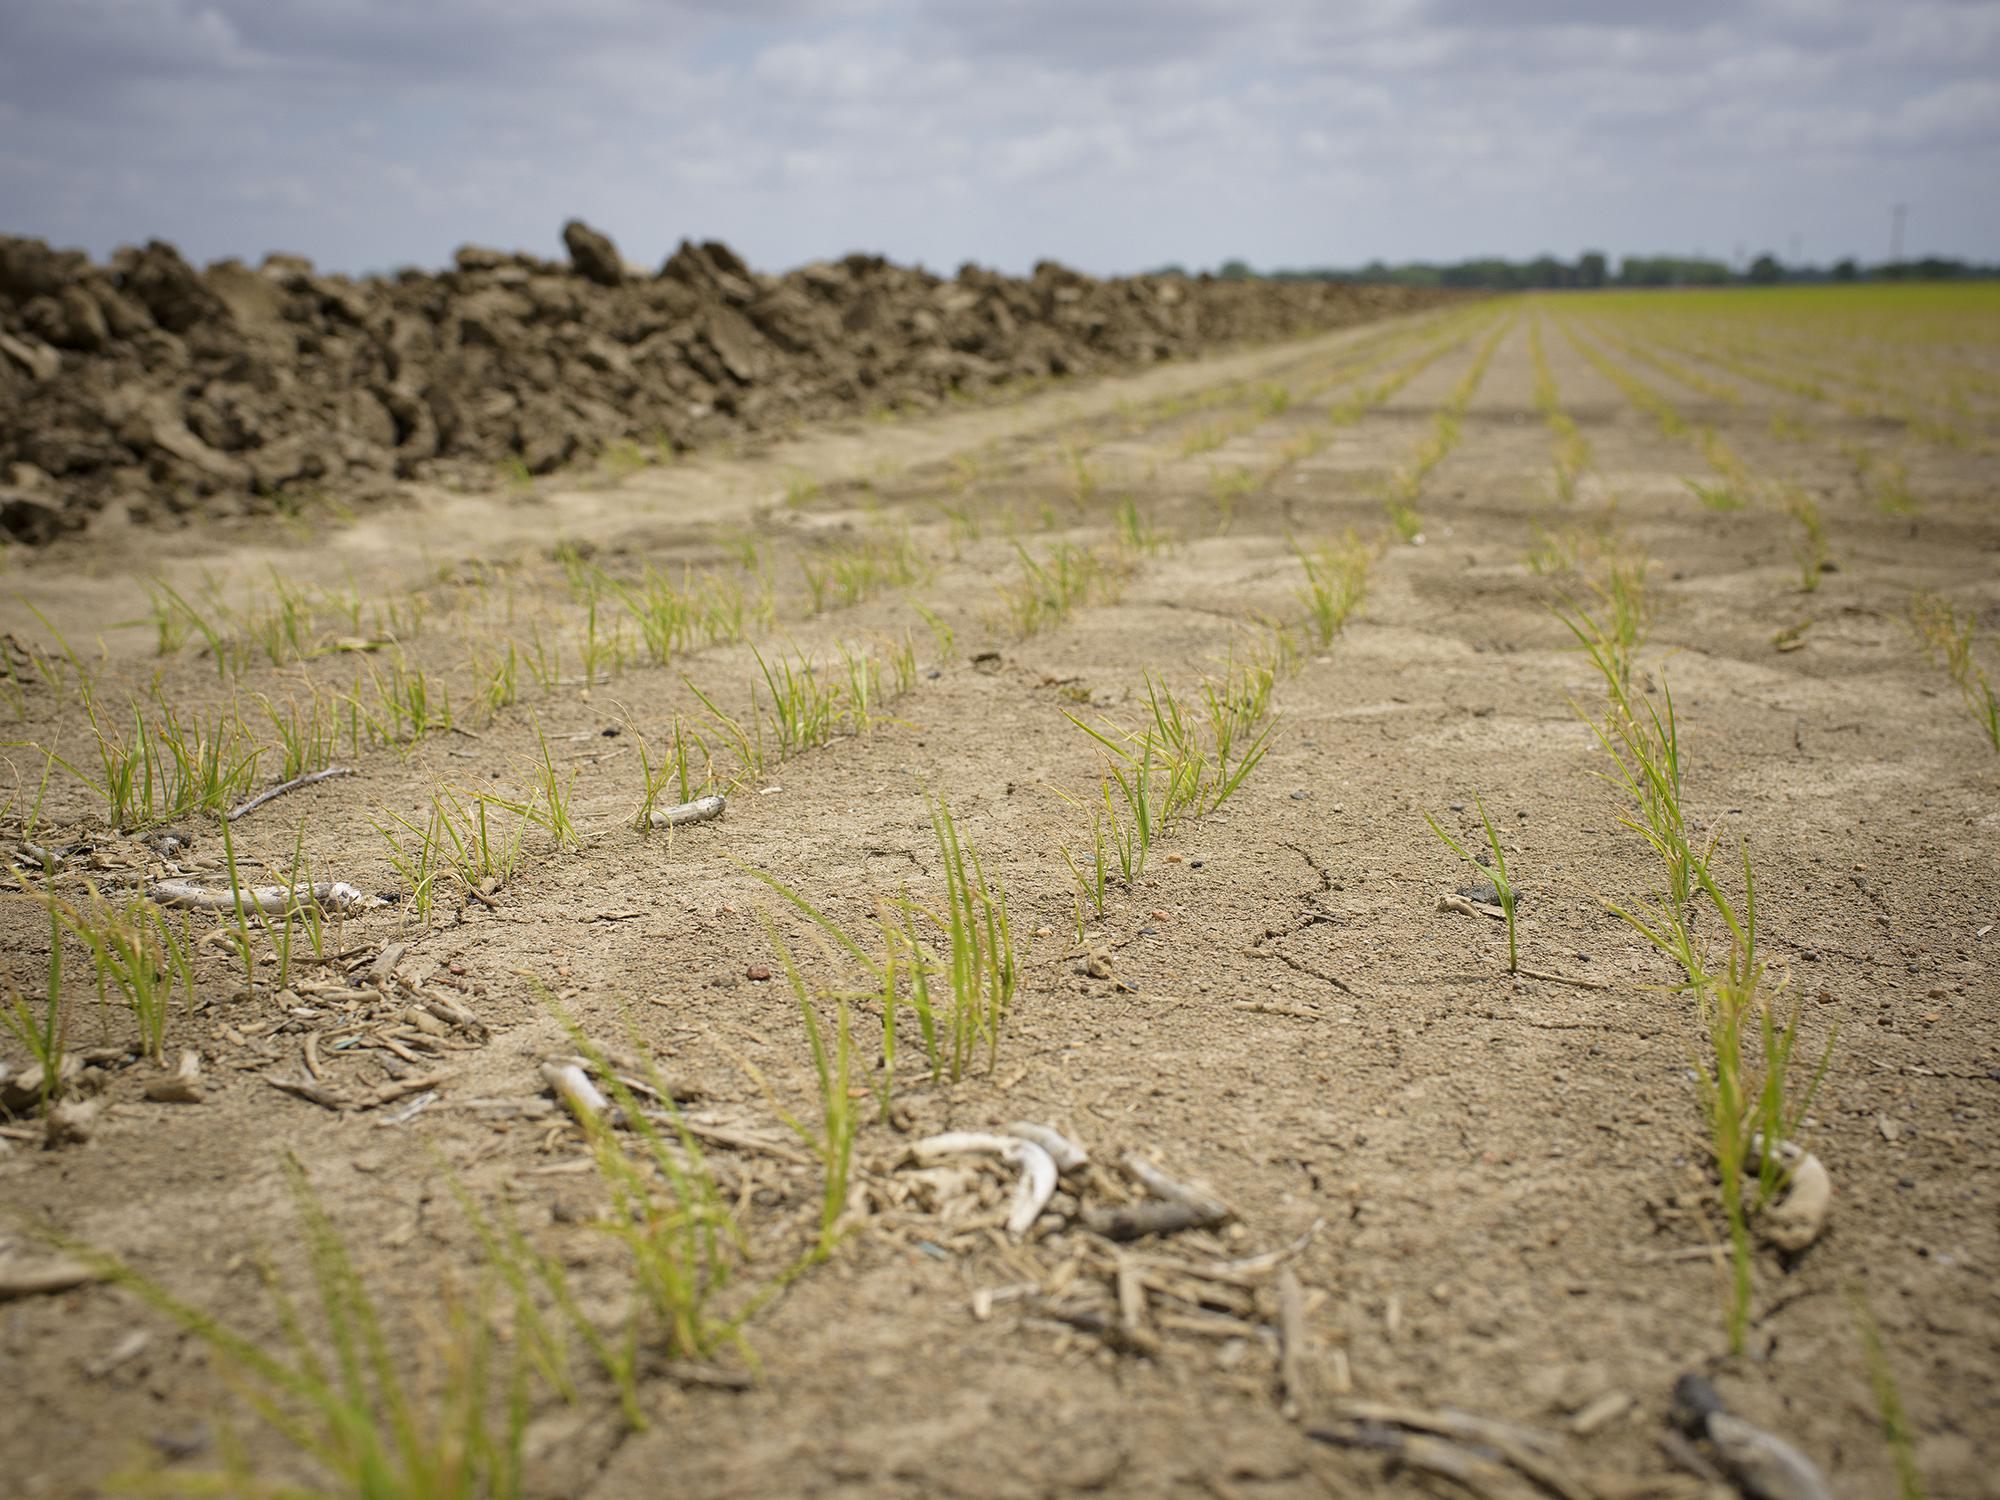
0;222;1428;544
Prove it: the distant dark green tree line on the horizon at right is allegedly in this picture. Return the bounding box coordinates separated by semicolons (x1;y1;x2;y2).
1162;250;2000;292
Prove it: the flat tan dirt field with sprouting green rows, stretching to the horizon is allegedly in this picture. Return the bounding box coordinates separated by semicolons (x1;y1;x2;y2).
0;294;2000;1500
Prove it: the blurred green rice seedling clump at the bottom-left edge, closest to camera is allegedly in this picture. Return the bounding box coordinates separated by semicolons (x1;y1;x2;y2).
76;1154;530;1500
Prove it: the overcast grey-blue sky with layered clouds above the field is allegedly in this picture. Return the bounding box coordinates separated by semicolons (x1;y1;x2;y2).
0;0;2000;272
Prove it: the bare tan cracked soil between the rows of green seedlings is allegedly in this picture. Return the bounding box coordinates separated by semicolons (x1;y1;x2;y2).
0;302;2000;1500
